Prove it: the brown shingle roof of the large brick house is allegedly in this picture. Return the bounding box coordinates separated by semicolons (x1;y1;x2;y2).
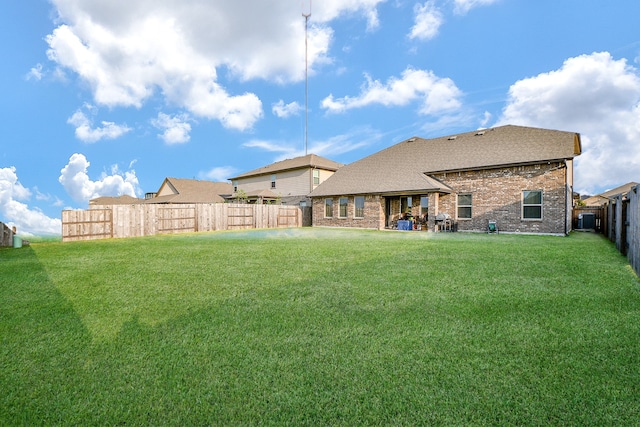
311;125;581;197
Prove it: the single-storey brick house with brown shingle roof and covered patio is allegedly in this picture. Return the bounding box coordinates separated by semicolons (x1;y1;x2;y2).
311;125;581;234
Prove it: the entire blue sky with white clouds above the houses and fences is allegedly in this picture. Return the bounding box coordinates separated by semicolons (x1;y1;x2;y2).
0;0;640;235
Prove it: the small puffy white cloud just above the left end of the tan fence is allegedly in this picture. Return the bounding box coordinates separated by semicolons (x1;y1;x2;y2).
58;153;142;203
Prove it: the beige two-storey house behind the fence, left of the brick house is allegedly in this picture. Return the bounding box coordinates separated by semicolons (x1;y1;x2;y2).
229;154;343;205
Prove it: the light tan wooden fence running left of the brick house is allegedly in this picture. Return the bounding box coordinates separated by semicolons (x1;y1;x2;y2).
62;203;303;242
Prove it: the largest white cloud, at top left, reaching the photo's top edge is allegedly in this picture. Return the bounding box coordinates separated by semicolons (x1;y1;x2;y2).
46;0;384;130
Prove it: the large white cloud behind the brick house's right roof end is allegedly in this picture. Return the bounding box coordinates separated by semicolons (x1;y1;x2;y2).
497;52;640;194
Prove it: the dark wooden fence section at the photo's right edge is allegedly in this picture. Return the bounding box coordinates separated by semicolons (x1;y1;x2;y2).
607;185;640;275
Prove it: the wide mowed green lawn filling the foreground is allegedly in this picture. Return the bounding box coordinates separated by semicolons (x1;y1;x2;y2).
0;229;640;426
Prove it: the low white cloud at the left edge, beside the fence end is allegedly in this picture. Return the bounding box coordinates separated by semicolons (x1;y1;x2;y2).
0;167;62;235
